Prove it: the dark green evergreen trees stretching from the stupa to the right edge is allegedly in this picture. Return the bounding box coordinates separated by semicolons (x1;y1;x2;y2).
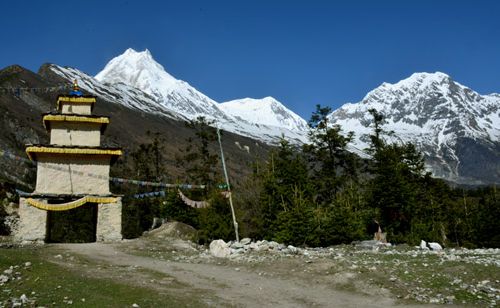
112;105;500;248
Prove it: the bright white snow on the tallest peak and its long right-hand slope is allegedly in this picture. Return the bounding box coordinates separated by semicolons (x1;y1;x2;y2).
95;48;305;143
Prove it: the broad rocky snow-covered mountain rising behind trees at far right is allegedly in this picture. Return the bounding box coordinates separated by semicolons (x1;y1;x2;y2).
330;72;500;183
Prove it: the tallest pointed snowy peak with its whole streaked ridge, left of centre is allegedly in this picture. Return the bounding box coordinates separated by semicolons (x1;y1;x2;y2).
49;49;306;144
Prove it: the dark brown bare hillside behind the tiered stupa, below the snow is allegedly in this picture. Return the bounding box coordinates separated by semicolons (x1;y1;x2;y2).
0;65;269;188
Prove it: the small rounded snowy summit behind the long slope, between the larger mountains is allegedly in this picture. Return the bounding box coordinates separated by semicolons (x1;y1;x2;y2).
219;96;307;132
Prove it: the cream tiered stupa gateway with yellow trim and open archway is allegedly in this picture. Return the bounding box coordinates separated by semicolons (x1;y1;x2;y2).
15;80;122;241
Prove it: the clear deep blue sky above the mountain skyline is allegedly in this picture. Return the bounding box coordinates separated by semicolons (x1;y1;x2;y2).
0;0;500;120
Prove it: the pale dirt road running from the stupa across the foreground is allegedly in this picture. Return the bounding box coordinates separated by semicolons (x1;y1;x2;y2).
56;243;422;307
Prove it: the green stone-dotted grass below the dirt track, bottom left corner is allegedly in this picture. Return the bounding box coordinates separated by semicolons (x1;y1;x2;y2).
0;247;205;307
